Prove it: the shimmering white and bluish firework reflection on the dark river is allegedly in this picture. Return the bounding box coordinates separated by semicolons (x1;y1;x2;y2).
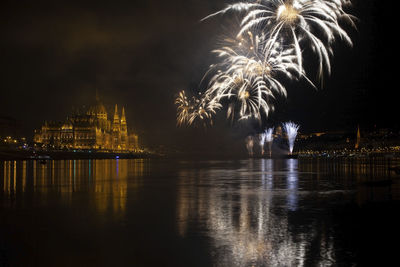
177;159;390;266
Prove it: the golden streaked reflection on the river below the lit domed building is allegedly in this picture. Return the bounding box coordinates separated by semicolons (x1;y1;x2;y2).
0;159;145;215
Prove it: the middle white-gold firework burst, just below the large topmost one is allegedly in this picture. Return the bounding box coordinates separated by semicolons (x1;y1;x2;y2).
205;31;305;121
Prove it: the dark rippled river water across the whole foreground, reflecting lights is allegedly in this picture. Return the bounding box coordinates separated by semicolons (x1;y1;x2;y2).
0;159;400;266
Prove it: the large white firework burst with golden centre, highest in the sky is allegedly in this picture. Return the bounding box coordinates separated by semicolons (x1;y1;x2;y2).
204;0;354;78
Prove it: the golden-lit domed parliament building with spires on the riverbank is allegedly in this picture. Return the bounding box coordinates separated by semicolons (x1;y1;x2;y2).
34;95;139;152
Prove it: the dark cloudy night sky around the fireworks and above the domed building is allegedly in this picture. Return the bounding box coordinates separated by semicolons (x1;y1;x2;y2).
0;0;399;154
